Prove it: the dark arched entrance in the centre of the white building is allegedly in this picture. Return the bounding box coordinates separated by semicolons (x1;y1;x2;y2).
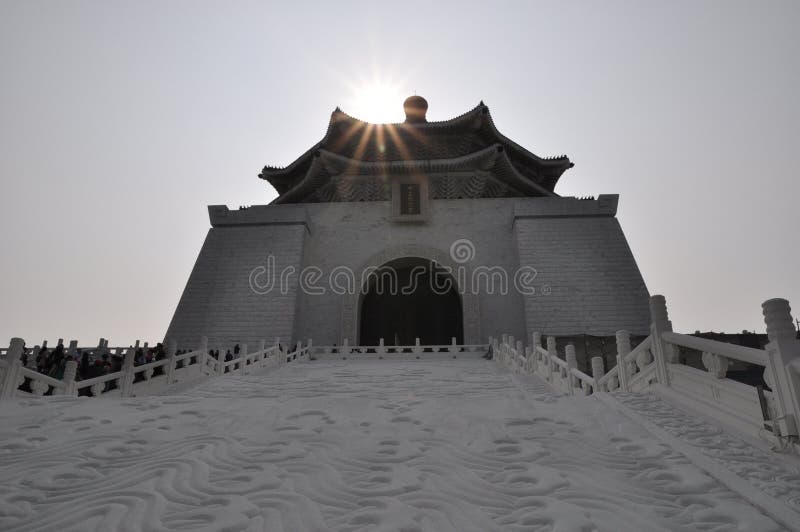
359;257;464;345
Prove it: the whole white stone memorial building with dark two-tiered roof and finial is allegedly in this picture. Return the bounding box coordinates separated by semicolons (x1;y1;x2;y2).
167;96;649;347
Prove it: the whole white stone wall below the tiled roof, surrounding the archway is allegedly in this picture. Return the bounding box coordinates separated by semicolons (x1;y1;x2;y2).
162;196;649;347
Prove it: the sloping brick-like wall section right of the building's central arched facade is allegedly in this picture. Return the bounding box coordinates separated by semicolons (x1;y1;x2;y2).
514;195;650;336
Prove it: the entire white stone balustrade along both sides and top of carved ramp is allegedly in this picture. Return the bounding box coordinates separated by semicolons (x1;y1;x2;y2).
0;295;800;456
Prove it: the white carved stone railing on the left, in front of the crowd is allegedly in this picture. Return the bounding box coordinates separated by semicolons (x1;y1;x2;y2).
0;337;310;398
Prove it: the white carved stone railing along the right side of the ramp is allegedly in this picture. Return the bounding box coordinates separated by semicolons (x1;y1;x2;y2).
490;295;800;450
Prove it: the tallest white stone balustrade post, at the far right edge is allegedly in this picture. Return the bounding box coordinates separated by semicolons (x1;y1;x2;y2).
761;299;800;437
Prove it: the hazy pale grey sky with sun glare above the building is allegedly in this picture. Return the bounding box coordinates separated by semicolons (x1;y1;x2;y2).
0;0;800;345
